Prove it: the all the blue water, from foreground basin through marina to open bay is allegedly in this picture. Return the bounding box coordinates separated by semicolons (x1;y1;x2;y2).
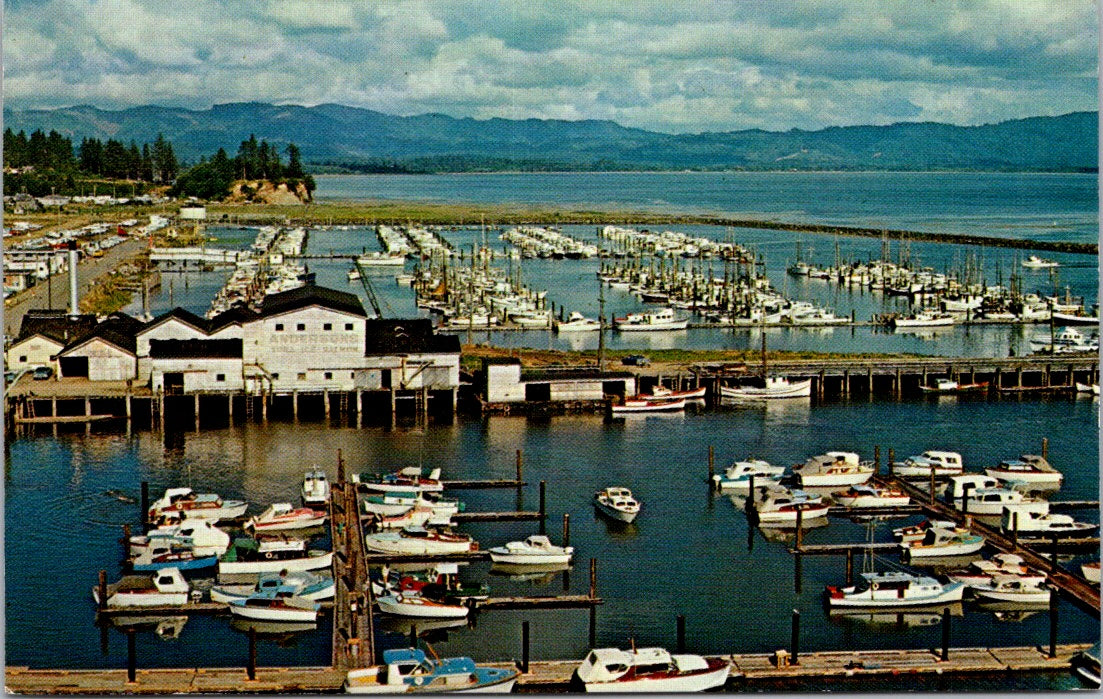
4;173;1100;690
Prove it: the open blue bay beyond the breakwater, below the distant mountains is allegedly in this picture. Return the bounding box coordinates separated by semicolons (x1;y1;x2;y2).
317;172;1099;243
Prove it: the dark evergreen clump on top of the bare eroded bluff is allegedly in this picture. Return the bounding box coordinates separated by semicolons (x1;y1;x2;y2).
172;135;314;200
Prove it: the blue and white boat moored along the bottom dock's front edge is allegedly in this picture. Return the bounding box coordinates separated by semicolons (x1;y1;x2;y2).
344;648;521;695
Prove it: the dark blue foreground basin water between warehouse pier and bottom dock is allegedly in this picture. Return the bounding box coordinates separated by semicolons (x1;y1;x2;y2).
4;398;1099;679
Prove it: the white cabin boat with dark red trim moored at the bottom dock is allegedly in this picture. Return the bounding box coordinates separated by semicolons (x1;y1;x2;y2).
575;648;731;695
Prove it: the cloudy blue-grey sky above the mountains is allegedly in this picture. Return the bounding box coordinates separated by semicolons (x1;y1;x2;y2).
2;0;1100;133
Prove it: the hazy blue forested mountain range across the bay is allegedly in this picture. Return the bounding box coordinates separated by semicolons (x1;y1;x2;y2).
3;103;1099;172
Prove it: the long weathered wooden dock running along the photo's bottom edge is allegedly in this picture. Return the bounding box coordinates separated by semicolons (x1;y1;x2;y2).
12;643;1092;695
